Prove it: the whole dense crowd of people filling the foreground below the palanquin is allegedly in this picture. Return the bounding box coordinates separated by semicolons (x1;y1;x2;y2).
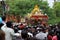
0;16;60;40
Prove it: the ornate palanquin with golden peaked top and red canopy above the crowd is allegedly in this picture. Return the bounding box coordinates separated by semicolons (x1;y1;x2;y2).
27;5;48;24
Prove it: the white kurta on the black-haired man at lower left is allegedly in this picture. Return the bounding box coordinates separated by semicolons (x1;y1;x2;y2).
1;25;14;40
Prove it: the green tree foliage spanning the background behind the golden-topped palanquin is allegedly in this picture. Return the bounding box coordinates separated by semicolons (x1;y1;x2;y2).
0;0;60;23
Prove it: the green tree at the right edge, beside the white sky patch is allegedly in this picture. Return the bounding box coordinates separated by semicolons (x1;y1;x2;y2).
49;2;60;24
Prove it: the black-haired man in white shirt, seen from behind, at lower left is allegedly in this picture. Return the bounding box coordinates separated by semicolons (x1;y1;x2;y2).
1;22;19;40
